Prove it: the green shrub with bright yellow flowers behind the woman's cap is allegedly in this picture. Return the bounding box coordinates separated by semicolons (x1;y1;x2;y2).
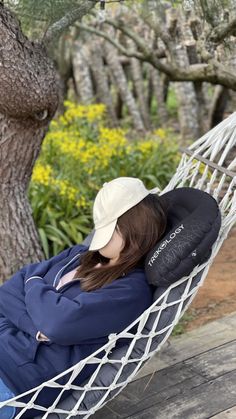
29;101;179;257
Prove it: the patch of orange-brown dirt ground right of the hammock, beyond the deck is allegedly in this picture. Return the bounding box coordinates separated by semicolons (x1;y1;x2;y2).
185;226;236;330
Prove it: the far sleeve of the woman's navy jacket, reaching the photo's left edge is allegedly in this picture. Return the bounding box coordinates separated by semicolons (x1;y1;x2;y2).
0;247;84;337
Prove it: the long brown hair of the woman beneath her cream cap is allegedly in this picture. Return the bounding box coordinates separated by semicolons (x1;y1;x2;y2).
74;194;167;291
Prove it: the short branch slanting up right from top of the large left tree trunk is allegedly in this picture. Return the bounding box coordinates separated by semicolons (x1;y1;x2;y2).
43;0;100;46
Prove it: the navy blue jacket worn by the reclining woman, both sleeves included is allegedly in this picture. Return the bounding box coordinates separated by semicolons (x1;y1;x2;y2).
0;245;152;405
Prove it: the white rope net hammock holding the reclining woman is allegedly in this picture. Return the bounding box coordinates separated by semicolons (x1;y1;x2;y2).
0;112;236;419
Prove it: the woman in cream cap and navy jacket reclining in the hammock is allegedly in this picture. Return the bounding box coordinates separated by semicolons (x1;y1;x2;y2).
0;177;166;419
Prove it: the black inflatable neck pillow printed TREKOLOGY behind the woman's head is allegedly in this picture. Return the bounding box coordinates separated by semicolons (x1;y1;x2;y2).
145;187;221;286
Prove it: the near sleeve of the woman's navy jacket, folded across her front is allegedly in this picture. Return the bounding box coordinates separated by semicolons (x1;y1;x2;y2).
25;274;152;345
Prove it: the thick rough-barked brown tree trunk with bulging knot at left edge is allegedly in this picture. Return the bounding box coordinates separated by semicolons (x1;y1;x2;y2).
0;3;58;281
